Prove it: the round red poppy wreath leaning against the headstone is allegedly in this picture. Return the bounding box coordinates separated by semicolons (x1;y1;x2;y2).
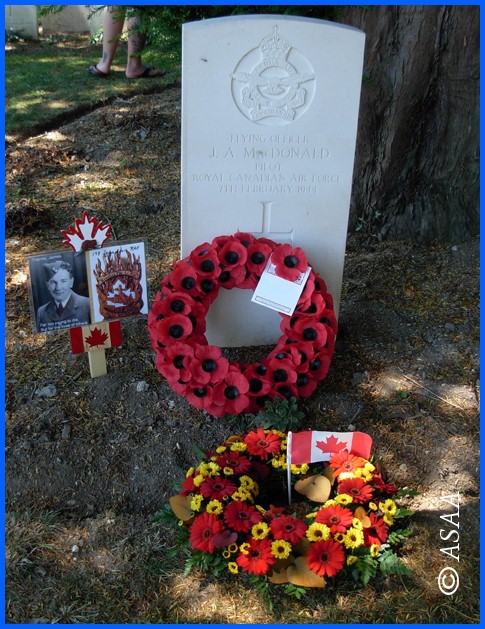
148;232;337;417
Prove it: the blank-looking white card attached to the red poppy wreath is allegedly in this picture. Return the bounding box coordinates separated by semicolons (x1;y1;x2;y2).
251;258;311;316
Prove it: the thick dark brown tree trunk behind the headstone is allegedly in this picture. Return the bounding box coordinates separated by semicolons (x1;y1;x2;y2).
341;5;480;242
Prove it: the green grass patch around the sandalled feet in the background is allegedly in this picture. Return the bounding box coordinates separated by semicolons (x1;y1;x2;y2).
5;35;179;138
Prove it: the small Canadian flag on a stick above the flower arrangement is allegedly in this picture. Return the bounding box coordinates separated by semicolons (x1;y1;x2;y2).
288;430;372;465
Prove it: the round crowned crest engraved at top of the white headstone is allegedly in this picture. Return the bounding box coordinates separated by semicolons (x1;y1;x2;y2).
231;26;315;126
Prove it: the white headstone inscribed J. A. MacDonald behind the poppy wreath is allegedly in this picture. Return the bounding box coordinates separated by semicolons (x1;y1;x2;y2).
182;15;365;347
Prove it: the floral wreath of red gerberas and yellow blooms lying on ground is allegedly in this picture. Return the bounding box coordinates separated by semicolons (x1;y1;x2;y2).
163;428;414;587
